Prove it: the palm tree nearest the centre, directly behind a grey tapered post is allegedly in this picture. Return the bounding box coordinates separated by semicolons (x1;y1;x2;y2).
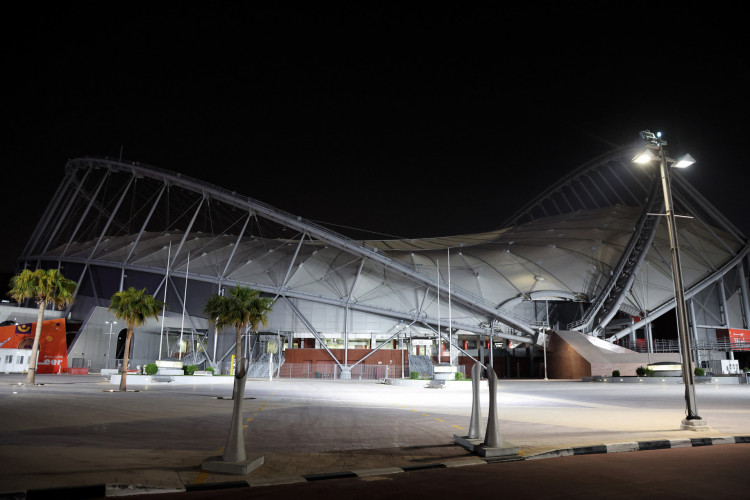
204;285;273;374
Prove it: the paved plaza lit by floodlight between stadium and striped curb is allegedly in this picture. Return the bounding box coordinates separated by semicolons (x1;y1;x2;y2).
0;375;750;496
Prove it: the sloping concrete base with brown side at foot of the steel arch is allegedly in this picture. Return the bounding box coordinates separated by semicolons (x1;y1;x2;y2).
547;330;680;379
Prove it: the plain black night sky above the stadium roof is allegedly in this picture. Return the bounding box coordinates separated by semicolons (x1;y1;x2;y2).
0;2;750;278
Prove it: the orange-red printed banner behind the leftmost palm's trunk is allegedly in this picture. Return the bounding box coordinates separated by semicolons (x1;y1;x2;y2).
0;319;68;373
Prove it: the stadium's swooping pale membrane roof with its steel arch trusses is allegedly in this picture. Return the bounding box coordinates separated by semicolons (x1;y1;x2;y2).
22;149;746;341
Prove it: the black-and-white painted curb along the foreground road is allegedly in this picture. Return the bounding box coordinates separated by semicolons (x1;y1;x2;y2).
11;436;750;500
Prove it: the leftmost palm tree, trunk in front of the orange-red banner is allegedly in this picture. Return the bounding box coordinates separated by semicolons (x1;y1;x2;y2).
8;269;77;385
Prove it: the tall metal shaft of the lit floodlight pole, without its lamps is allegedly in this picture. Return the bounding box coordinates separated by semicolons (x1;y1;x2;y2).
658;140;702;424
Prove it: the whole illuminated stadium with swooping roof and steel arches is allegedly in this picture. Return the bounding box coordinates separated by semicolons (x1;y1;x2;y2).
0;141;750;378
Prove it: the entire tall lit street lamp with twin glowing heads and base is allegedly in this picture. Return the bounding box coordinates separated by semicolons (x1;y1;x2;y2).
633;130;708;430
